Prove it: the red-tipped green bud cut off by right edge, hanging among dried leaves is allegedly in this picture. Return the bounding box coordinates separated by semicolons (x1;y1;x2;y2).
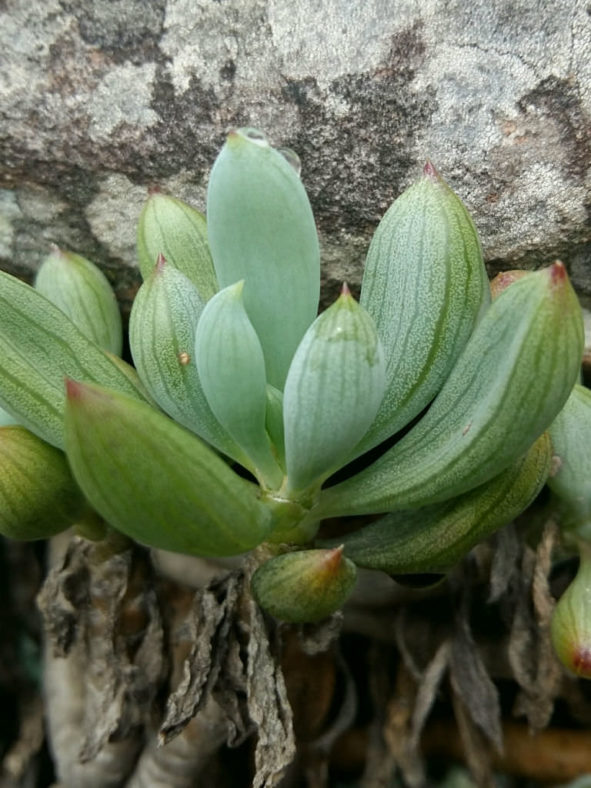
551;545;591;679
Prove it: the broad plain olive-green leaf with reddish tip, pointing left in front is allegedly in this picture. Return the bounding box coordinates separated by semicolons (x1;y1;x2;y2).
65;381;269;556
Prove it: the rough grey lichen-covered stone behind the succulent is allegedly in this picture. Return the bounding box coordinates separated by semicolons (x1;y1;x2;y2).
0;0;591;314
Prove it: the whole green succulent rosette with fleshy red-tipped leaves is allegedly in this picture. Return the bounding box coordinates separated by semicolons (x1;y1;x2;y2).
0;129;583;622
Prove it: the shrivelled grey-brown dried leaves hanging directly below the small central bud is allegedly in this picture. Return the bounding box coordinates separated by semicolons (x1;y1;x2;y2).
161;573;295;788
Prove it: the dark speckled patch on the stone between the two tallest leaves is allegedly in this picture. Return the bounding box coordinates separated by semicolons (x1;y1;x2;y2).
283;23;436;232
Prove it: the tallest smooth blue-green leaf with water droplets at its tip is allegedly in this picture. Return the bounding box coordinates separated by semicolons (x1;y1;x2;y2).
207;129;320;390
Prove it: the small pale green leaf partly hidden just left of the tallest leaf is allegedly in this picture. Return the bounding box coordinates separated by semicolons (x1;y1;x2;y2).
137;192;217;301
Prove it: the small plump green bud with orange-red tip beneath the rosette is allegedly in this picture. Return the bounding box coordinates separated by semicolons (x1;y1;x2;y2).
251;547;357;624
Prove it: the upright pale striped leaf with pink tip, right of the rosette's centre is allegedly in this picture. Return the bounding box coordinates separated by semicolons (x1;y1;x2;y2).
283;286;385;497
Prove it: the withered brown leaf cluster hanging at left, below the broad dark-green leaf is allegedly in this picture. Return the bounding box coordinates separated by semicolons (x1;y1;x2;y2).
38;537;165;762
